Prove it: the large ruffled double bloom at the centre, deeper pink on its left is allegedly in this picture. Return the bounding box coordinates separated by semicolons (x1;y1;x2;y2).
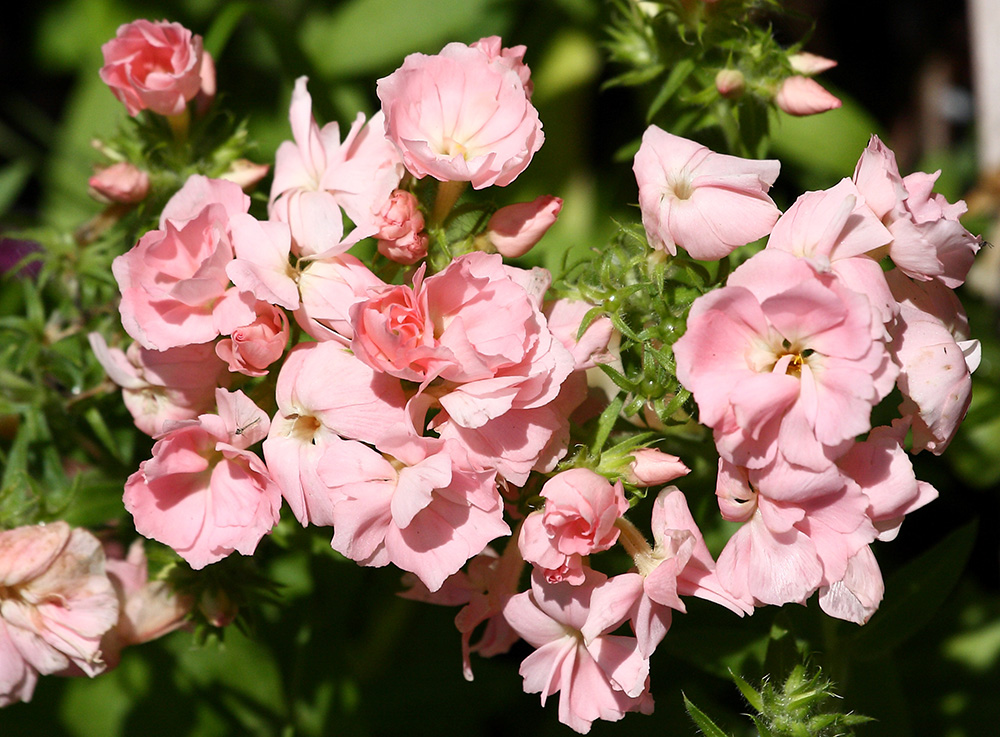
351;251;575;484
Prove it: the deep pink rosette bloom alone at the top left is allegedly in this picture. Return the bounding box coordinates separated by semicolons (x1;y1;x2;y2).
101;20;205;116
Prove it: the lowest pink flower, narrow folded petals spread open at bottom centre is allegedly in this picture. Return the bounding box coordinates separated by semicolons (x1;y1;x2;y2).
503;570;653;734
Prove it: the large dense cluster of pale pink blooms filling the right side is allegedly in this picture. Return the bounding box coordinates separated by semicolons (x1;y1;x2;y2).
674;132;979;623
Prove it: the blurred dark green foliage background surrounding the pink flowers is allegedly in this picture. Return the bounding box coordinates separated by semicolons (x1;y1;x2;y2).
0;0;1000;737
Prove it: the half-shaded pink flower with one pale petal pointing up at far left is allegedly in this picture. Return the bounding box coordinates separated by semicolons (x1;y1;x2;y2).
88;333;230;436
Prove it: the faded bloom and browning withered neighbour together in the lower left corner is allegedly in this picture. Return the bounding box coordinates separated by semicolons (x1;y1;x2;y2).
0;521;187;706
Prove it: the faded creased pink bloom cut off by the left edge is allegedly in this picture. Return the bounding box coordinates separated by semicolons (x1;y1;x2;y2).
0;520;118;706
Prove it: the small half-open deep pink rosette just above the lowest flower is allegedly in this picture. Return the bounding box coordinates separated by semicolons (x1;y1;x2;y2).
518;468;628;586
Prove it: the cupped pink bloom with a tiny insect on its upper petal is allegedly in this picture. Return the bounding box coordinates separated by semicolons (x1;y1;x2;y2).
124;389;281;569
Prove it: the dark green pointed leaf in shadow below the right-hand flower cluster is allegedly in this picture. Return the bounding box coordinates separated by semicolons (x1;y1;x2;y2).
849;520;978;661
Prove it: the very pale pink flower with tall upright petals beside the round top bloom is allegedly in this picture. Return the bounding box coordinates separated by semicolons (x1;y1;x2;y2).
268;77;403;256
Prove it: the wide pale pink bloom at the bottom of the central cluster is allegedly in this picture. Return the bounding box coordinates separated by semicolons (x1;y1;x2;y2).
318;435;510;591
